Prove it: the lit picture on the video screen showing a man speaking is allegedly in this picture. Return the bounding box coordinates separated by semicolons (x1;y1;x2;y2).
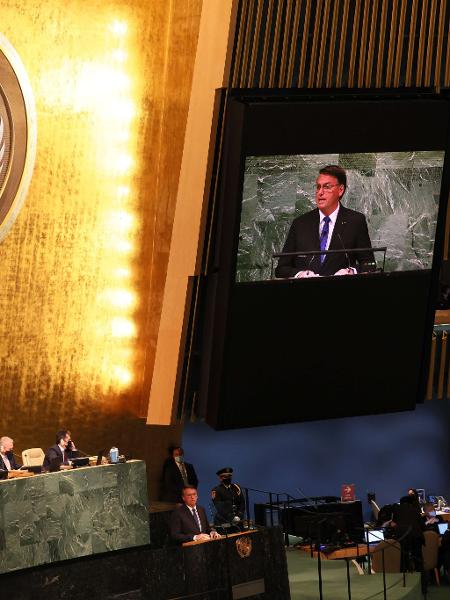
236;150;444;282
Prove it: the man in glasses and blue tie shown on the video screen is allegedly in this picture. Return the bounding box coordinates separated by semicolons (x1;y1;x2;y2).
275;165;376;279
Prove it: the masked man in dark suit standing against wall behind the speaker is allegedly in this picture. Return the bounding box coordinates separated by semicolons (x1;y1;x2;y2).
161;445;198;504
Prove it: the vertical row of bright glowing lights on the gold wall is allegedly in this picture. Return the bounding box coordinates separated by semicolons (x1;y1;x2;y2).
102;21;137;387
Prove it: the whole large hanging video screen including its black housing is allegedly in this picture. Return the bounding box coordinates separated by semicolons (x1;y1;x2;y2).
198;90;450;429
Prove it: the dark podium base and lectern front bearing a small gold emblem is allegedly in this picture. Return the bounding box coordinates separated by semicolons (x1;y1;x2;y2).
1;527;290;600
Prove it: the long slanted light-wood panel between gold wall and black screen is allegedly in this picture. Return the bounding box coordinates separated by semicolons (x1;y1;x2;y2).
147;0;237;425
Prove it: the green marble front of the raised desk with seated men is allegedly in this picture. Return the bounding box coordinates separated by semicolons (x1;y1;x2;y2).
0;460;150;573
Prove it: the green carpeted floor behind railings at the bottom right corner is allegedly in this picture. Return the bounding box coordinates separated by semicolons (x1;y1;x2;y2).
287;548;450;600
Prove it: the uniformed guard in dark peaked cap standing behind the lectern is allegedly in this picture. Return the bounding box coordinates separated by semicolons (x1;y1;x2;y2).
211;467;245;529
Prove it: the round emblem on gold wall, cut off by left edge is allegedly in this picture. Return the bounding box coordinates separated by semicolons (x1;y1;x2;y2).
0;33;37;241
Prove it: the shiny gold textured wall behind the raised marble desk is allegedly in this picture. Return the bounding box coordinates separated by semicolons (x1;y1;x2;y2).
0;0;201;496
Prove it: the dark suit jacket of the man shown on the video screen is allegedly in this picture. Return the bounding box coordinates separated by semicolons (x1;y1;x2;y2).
275;205;375;277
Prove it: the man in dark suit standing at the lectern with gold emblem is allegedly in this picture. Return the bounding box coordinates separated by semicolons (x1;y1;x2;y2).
170;486;220;544
